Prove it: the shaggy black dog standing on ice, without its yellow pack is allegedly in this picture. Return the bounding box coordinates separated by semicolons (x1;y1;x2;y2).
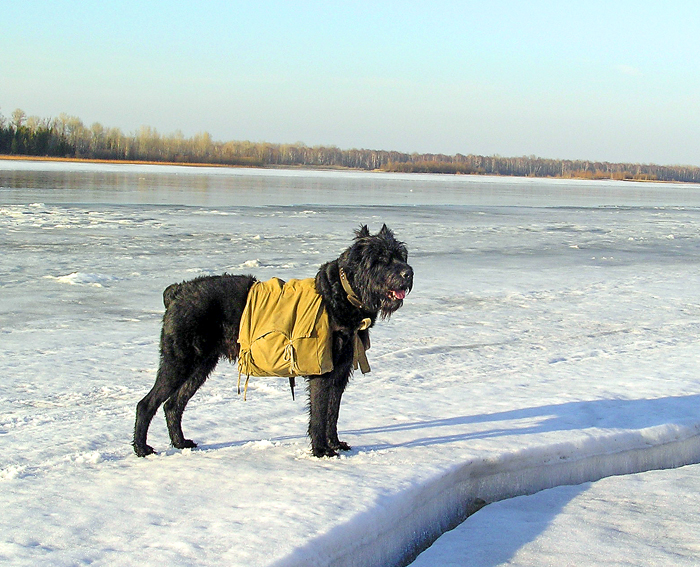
133;225;413;457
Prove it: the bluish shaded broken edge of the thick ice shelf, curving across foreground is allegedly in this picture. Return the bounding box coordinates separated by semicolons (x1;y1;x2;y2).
273;422;700;567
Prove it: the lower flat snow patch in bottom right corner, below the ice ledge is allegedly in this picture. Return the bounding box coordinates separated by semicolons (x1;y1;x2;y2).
411;465;700;567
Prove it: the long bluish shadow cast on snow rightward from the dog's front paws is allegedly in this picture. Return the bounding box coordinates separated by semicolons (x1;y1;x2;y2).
344;394;700;451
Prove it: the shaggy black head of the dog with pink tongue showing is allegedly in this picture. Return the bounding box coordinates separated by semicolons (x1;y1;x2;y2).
338;225;413;317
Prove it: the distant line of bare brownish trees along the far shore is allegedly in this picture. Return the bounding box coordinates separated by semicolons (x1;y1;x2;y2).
0;109;700;182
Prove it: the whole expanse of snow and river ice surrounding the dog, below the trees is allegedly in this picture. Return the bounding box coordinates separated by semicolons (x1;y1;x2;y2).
0;161;700;566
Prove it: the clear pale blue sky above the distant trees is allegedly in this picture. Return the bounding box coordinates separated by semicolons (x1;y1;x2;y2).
0;0;700;166
